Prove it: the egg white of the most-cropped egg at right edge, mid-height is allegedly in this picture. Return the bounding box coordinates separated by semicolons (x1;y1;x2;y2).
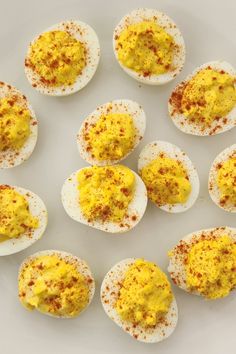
208;144;236;213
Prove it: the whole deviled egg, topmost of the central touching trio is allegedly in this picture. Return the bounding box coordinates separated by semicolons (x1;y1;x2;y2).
77;99;146;166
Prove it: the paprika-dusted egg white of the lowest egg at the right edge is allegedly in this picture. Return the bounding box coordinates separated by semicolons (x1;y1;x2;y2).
168;226;236;295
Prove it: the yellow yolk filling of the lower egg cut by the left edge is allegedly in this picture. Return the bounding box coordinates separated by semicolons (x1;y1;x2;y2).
0;185;39;241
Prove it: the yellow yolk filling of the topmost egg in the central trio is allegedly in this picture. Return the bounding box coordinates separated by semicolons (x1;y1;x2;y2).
85;113;135;161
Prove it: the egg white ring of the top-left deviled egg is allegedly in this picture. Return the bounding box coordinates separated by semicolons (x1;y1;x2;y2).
25;21;100;96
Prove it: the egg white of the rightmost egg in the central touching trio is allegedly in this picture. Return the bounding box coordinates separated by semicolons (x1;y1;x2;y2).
138;140;200;213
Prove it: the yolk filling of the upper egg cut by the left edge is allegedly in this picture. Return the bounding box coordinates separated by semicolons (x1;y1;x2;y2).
0;98;31;151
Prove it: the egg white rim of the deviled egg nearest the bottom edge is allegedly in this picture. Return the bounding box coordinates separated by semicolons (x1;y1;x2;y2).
101;258;178;343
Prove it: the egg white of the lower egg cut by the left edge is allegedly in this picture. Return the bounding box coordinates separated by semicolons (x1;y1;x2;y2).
0;186;48;256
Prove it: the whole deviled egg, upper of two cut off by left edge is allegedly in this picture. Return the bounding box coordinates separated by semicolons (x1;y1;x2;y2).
0;82;38;168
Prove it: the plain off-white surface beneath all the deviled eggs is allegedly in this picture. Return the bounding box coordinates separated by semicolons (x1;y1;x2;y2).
0;0;236;354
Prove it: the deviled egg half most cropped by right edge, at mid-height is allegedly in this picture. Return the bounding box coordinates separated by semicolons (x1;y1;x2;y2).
208;144;236;213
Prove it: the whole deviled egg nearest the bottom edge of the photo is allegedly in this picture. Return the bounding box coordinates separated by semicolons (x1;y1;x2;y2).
101;258;178;343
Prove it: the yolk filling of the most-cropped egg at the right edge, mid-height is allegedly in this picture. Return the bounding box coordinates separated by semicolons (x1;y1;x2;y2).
217;156;236;207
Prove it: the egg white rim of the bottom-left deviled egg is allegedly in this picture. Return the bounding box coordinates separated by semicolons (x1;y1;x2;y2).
18;250;95;319
